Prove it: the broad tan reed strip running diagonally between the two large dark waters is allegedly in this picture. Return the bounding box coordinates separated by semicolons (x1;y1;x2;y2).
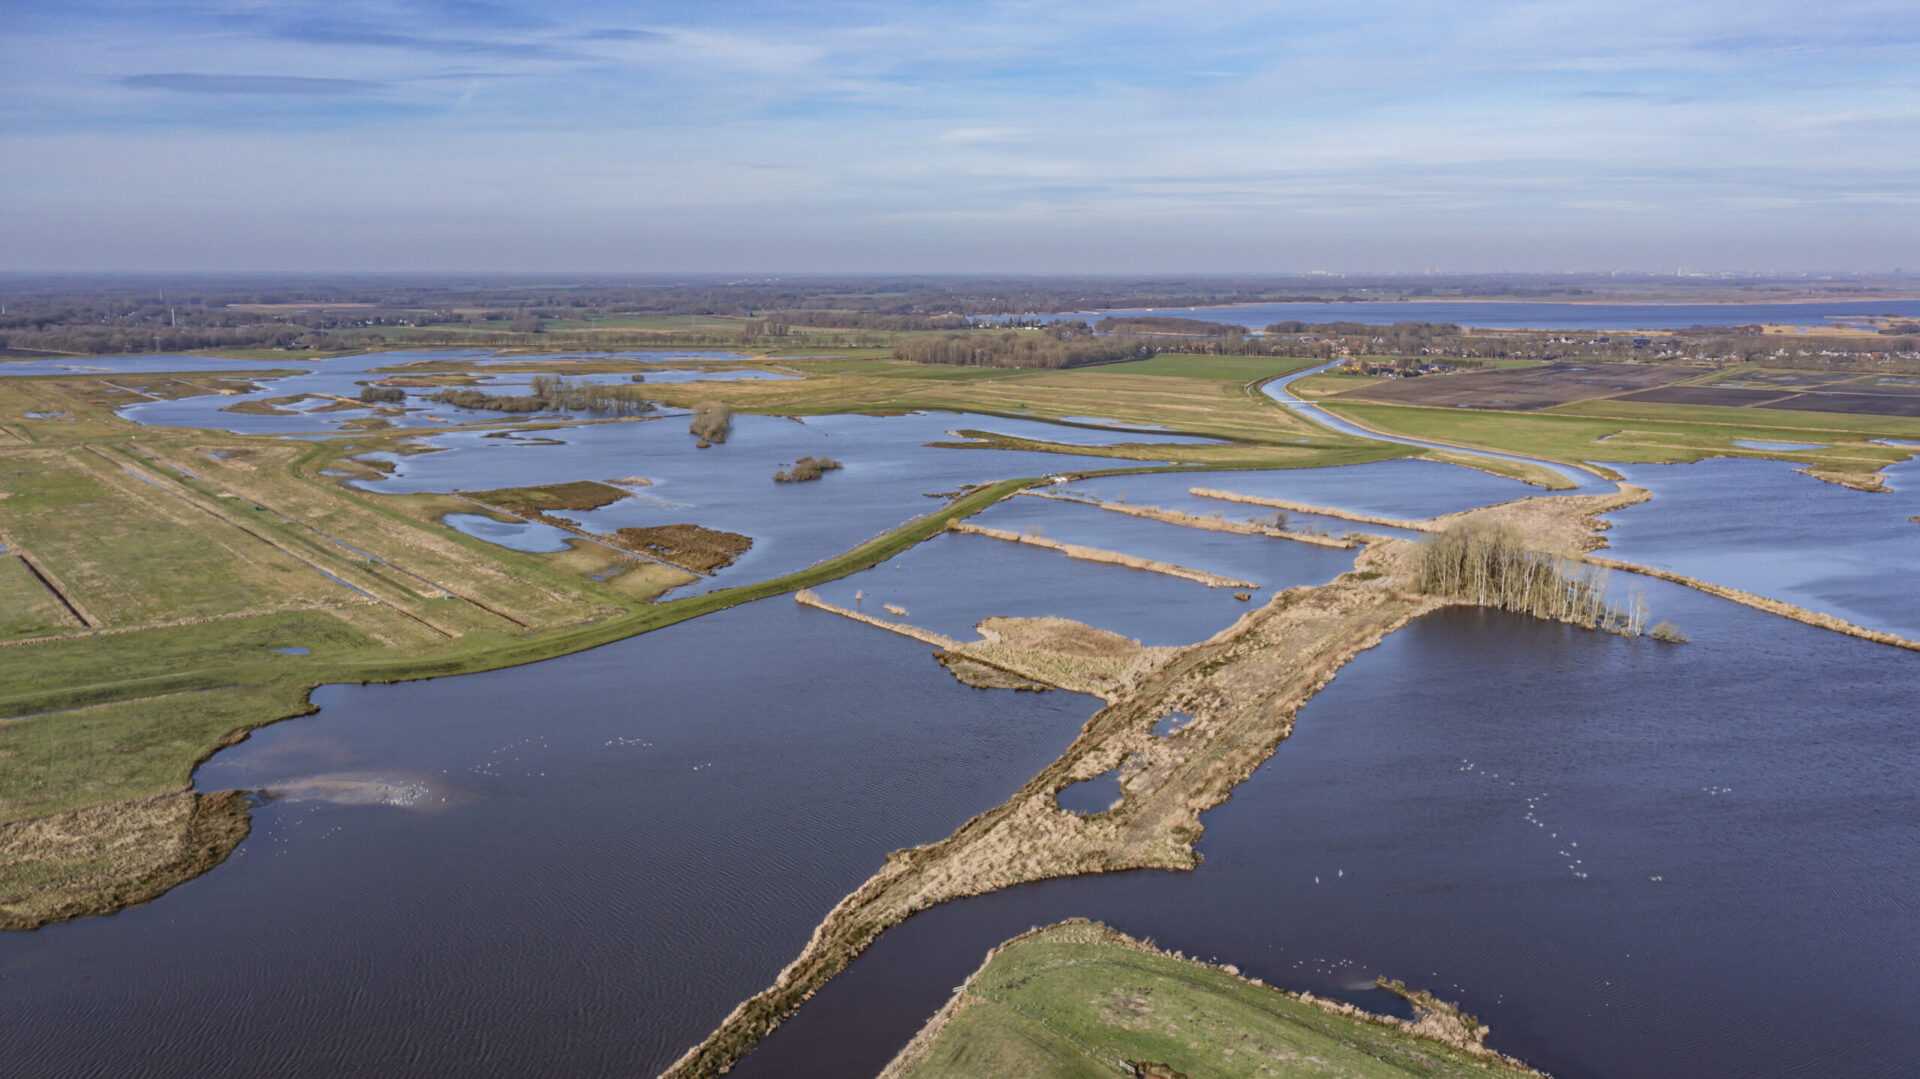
664;541;1448;1079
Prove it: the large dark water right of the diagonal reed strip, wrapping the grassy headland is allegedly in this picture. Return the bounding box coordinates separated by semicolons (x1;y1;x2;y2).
733;582;1920;1079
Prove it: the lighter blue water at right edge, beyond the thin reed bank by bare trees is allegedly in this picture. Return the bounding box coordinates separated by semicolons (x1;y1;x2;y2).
1605;457;1920;639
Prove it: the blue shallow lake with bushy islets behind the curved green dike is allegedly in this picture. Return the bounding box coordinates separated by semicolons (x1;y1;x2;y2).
361;413;1179;587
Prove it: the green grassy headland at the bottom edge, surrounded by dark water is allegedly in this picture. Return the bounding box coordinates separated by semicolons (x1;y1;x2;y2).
887;922;1534;1079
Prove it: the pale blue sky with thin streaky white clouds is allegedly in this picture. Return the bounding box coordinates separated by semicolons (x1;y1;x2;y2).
0;0;1920;273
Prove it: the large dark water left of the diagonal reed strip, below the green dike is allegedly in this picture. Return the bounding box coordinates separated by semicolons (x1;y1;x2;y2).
0;597;1098;1077
